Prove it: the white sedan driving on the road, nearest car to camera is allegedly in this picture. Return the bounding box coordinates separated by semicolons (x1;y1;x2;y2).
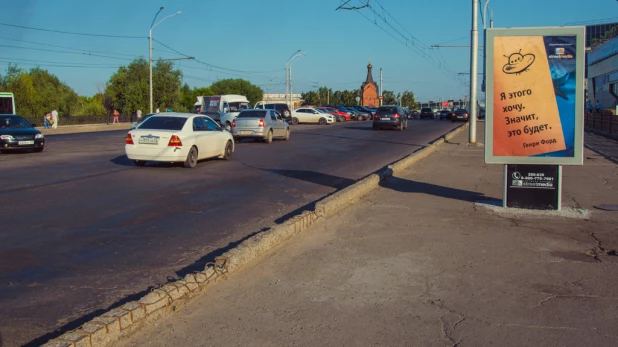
125;113;234;168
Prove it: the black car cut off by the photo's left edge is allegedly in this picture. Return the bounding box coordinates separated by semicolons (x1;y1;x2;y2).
0;114;45;152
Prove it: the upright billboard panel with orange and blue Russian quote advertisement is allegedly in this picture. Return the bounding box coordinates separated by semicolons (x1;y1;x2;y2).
485;27;585;165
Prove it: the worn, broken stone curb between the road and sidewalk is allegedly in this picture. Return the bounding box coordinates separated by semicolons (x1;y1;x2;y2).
43;123;468;347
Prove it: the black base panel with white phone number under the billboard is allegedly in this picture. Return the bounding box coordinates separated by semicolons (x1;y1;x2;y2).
504;164;560;210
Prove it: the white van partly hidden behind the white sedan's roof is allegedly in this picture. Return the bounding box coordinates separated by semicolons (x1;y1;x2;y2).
200;94;253;132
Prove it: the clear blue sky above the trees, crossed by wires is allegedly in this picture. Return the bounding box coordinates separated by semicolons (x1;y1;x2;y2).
0;0;618;101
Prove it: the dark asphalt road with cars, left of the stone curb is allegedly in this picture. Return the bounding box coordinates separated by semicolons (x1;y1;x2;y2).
0;120;457;346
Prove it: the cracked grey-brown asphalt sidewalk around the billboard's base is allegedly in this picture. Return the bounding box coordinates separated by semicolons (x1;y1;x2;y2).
116;123;618;346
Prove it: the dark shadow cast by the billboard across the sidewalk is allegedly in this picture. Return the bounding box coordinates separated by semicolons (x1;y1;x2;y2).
380;177;501;202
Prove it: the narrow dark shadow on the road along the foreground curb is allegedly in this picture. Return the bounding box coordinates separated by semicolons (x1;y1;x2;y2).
24;228;270;347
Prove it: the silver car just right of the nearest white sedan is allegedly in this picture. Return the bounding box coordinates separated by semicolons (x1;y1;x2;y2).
232;109;290;143
